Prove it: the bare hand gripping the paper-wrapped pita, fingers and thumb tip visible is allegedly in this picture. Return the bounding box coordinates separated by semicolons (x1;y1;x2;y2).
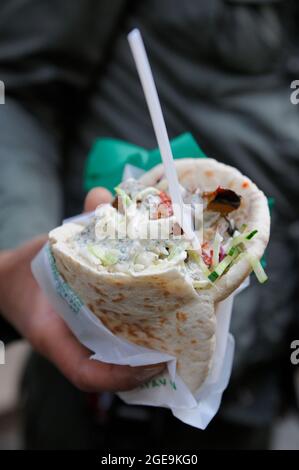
0;188;164;392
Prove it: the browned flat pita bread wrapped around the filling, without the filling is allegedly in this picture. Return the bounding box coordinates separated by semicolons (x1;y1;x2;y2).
49;159;270;392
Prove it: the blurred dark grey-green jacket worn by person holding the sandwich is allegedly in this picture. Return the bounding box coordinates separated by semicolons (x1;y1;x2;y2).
0;0;299;430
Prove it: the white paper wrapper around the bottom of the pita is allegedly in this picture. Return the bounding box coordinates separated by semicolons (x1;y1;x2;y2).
32;226;248;429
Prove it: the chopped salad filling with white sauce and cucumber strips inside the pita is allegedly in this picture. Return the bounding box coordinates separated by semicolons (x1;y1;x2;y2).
70;179;267;289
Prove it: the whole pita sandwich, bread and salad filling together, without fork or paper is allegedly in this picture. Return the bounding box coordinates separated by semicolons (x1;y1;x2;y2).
49;158;270;393
